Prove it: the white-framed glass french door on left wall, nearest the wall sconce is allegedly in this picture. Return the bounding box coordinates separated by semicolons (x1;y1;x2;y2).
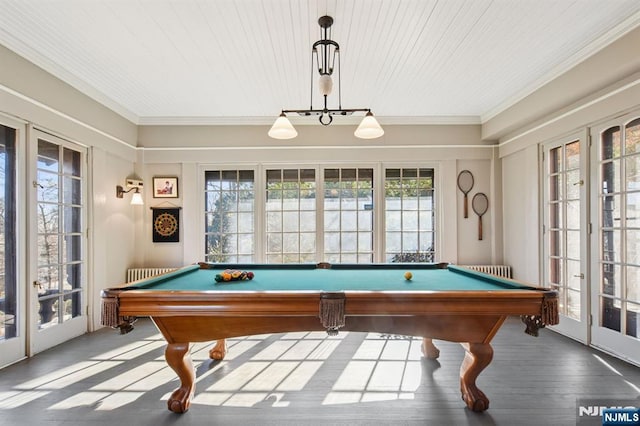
28;130;87;355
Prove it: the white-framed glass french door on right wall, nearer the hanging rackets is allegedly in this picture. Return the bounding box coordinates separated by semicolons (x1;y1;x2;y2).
542;133;589;343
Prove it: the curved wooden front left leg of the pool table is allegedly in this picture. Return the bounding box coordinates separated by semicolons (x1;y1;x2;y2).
164;343;196;413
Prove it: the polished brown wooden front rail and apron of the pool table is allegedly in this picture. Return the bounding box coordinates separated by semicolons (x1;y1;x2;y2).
102;289;557;341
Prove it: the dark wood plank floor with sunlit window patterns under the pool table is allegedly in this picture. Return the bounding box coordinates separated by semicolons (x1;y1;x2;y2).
0;318;640;426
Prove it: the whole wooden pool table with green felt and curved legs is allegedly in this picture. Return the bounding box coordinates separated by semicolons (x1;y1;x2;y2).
102;263;558;413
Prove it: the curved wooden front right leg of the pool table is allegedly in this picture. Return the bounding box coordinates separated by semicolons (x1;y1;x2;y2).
460;343;493;411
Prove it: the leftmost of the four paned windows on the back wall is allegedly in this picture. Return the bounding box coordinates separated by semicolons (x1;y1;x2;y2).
205;170;255;263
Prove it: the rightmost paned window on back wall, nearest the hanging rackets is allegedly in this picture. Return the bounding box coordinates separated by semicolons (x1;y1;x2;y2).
384;168;435;262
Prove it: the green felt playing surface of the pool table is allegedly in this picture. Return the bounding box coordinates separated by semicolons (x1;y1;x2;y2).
130;265;532;292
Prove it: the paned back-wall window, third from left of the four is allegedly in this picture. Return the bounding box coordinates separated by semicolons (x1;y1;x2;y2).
324;168;373;263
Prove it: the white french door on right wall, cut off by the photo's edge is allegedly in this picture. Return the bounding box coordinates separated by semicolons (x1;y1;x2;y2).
591;113;640;364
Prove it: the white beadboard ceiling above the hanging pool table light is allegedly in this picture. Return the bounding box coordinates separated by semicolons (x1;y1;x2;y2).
0;0;640;124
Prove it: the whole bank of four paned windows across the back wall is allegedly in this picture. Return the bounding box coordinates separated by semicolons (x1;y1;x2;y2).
203;166;436;263
